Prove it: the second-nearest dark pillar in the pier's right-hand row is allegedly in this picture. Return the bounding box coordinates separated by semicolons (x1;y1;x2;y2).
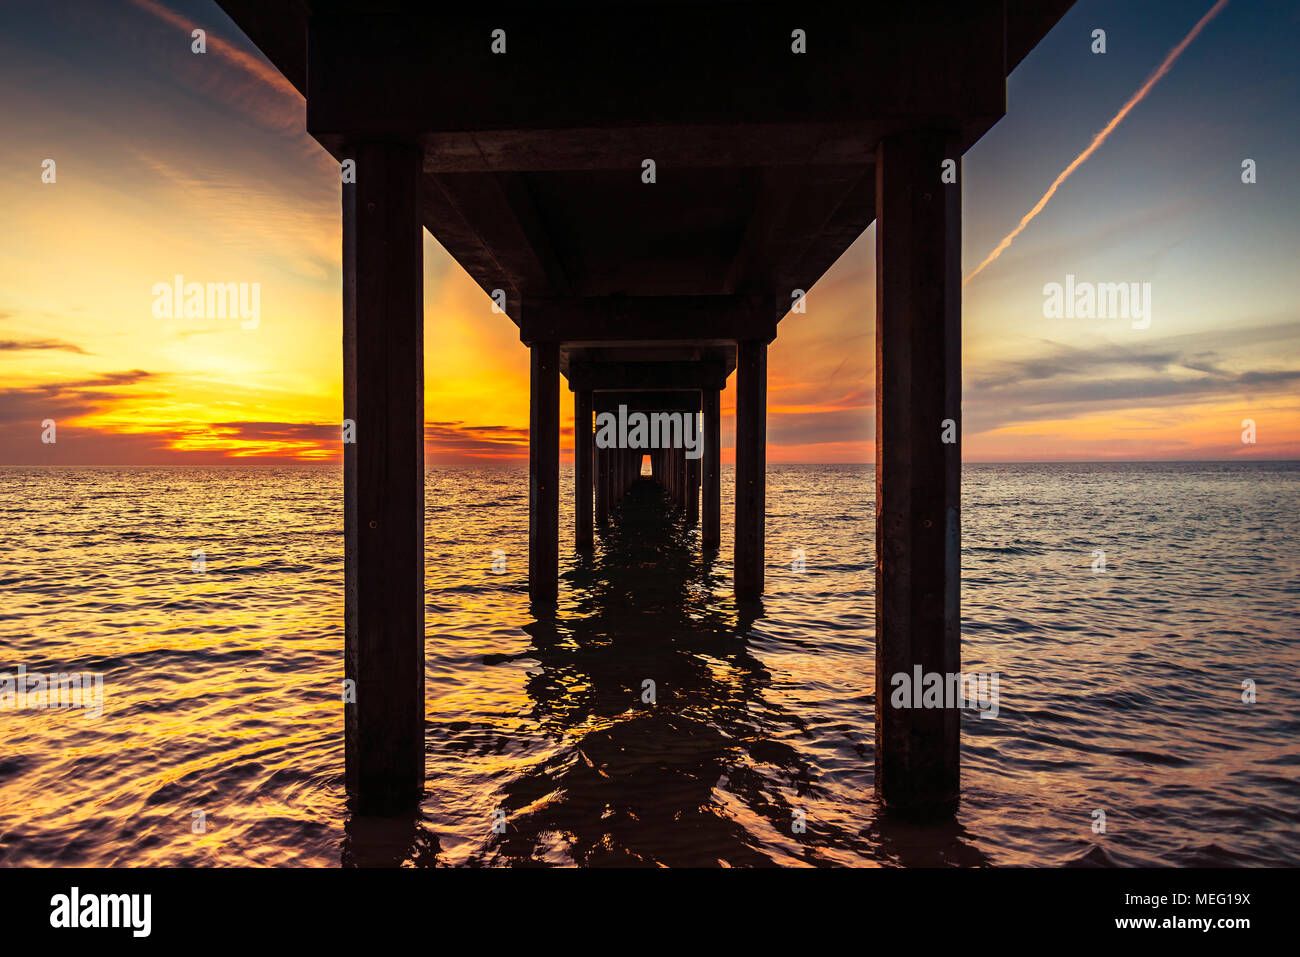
733;339;767;598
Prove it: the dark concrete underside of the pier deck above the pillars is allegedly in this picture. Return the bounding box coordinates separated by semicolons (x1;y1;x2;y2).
218;0;1073;356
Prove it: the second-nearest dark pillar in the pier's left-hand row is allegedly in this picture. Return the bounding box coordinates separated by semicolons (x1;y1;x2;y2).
528;342;560;602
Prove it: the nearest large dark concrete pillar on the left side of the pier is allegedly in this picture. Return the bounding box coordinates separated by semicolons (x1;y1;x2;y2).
343;143;424;815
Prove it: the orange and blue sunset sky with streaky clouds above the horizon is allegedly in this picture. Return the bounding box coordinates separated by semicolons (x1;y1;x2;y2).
0;0;1300;465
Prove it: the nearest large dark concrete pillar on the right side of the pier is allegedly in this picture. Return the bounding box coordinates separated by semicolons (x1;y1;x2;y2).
875;131;962;813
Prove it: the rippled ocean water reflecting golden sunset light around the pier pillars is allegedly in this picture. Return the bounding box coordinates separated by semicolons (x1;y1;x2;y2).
0;463;1300;866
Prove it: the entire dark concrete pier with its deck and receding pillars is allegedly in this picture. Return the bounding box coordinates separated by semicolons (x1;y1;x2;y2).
218;0;1084;815
